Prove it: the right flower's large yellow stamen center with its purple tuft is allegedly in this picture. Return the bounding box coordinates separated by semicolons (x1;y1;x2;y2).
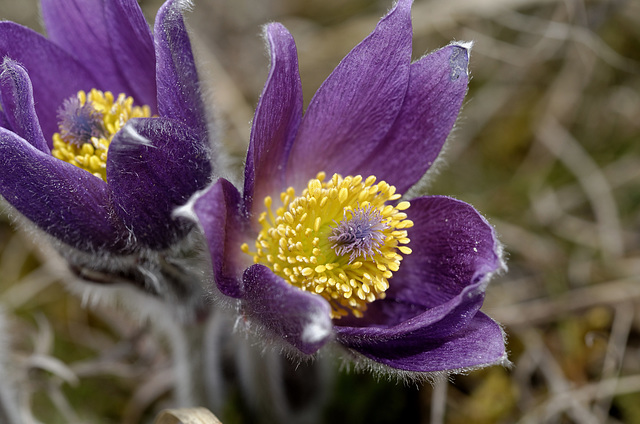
241;172;413;318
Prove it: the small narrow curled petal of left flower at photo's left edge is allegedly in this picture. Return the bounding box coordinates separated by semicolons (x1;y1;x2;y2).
0;58;50;153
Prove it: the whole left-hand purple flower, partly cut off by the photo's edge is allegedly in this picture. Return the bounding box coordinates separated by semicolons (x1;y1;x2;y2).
0;0;212;253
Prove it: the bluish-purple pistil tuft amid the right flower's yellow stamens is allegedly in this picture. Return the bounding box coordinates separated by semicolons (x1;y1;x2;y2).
328;204;389;263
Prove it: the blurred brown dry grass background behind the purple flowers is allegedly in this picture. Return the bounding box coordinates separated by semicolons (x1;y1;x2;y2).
0;0;640;424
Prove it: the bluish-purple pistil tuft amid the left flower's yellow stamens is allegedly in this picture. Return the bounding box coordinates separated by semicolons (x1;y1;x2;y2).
58;96;105;147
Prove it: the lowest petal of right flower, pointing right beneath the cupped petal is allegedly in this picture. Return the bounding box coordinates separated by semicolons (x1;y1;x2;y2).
342;312;506;372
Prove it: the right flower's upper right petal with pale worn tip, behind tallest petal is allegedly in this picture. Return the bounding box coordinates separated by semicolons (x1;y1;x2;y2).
354;44;469;193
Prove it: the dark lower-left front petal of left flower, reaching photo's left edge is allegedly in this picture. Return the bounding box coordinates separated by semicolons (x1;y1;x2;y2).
0;128;126;251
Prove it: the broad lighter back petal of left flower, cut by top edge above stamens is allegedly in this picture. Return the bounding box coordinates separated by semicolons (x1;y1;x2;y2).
40;0;133;96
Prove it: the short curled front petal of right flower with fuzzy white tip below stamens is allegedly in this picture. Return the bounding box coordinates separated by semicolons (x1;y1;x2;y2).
243;264;332;354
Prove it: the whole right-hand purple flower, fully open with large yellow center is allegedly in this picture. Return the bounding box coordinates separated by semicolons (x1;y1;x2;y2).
192;0;507;372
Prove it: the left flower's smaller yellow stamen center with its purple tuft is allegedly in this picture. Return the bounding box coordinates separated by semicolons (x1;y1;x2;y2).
51;89;151;181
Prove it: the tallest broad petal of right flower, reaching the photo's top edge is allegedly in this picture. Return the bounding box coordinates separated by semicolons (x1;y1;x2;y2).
287;0;412;187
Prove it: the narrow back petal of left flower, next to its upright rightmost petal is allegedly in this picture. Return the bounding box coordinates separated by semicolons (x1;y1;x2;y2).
104;0;158;113
